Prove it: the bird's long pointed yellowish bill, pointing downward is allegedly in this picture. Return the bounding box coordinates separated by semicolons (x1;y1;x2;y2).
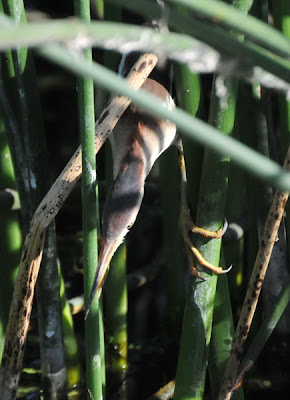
85;240;120;319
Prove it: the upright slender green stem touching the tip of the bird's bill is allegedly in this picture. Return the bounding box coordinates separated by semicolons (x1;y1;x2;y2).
75;0;104;400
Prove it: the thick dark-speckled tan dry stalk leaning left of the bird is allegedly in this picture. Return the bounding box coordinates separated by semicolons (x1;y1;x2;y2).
0;54;157;400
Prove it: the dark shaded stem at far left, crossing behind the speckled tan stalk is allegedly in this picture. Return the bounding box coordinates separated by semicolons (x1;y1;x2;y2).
1;0;66;400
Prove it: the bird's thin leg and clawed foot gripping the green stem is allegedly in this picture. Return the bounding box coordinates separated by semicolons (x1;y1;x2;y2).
179;144;231;277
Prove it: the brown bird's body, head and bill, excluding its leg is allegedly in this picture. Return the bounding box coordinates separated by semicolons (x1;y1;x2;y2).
86;72;177;316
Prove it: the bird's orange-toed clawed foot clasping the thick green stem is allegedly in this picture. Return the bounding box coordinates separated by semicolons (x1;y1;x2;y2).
179;209;232;279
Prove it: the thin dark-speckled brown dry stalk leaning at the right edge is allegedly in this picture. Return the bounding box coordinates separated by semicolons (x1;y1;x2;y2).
219;147;290;400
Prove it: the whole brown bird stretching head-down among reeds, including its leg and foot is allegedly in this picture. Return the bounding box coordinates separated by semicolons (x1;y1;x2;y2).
85;52;231;319
